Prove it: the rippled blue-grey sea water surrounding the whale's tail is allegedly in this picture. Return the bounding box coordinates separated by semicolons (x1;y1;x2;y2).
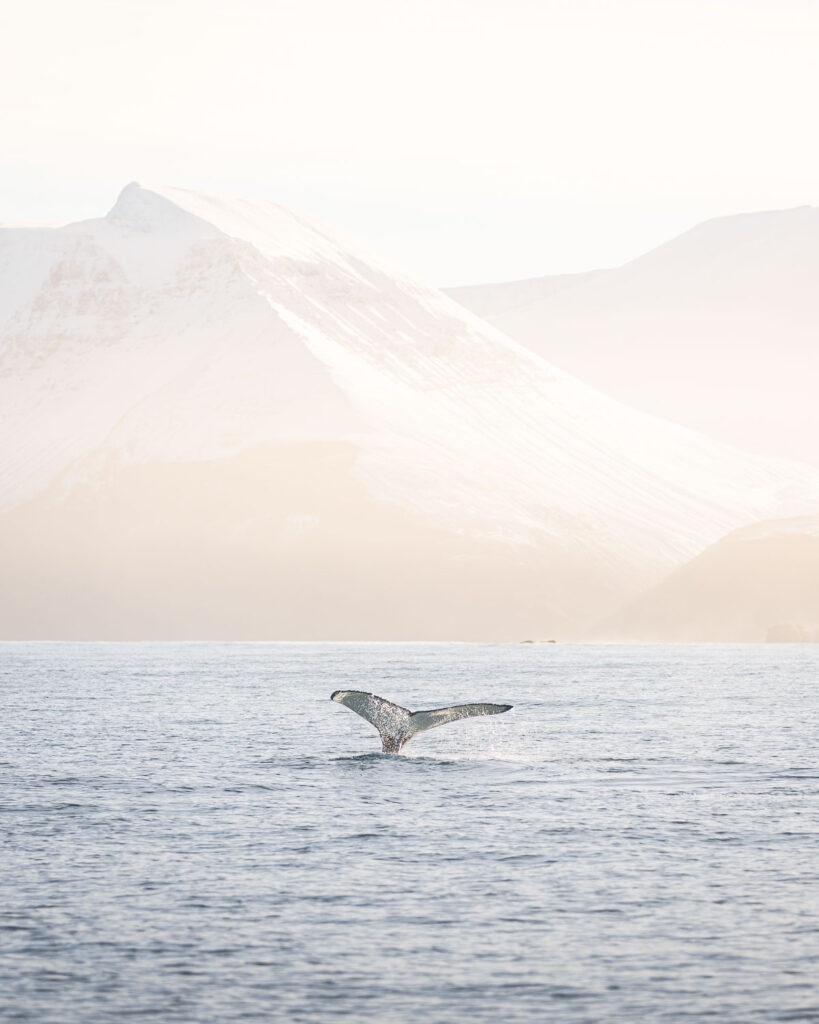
0;643;819;1024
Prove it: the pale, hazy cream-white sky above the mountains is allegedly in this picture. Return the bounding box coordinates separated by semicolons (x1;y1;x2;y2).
0;0;819;284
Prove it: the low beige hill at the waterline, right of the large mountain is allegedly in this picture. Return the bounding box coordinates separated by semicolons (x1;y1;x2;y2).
600;517;819;641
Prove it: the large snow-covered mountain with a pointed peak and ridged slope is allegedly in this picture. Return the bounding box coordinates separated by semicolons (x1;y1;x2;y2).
0;184;819;637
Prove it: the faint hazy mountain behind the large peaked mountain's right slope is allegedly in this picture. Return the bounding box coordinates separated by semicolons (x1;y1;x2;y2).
450;207;819;466
